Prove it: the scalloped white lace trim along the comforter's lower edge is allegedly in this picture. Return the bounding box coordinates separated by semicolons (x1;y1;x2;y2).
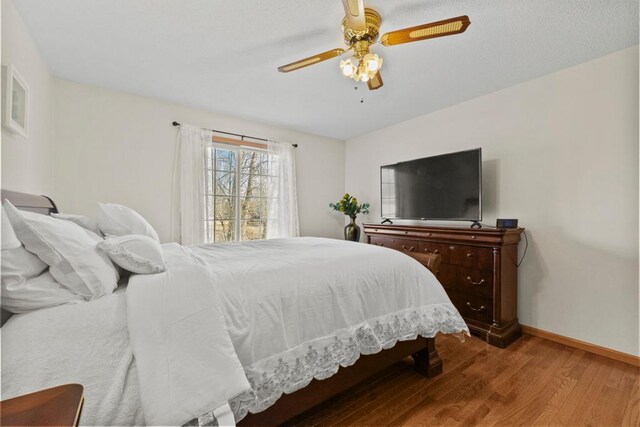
185;304;469;426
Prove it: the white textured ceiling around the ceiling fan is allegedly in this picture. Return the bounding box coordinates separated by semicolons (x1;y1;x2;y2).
15;0;638;139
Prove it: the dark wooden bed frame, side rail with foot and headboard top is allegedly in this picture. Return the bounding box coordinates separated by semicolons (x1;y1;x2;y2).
2;190;442;426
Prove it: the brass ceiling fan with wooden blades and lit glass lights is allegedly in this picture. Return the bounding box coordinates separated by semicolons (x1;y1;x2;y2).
278;0;471;90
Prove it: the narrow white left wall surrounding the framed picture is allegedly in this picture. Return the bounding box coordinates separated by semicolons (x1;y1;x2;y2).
2;0;53;194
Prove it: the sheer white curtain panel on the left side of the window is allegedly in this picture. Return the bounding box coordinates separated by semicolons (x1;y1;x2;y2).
171;124;212;245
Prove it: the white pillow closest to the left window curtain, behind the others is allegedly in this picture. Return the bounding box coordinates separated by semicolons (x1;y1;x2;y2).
97;203;160;241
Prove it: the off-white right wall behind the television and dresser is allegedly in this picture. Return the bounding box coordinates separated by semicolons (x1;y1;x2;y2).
346;46;639;355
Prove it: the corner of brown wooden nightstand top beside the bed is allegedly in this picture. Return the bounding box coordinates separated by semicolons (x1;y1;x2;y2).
0;384;84;426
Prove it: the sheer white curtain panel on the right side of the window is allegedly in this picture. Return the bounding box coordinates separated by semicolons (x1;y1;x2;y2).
267;141;300;239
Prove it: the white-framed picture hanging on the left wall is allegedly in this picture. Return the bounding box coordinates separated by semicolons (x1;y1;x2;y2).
2;65;29;138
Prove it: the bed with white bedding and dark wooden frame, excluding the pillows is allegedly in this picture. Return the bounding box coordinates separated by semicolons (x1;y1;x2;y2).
2;191;468;425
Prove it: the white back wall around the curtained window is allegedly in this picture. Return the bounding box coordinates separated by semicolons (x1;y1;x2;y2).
53;79;345;241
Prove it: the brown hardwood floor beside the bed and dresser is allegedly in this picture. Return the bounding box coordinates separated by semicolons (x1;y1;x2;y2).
294;335;640;426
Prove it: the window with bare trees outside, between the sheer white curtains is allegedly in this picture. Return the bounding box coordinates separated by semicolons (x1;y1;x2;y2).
204;144;278;243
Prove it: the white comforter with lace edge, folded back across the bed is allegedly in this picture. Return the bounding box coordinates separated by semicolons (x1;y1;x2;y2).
127;238;468;423
